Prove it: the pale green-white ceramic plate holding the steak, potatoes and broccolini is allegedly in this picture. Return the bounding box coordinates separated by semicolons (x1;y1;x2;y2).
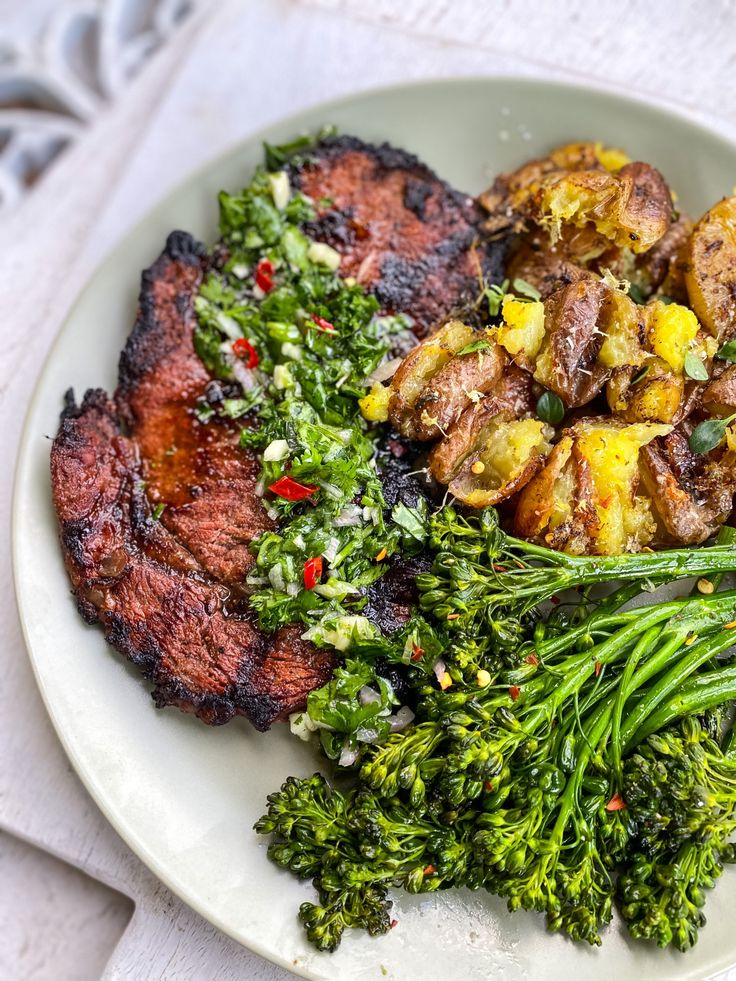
14;78;736;981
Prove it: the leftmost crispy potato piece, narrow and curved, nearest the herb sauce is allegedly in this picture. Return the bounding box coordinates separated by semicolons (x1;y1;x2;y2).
388;320;476;439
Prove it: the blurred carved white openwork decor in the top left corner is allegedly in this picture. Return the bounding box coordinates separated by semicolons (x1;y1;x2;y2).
0;0;194;215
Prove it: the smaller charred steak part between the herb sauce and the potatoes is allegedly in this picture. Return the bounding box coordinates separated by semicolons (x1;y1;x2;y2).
291;136;504;337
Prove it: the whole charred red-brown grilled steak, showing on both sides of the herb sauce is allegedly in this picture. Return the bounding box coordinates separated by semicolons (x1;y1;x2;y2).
51;138;501;729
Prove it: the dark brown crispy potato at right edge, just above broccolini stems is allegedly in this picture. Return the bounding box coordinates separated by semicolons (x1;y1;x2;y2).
640;426;736;545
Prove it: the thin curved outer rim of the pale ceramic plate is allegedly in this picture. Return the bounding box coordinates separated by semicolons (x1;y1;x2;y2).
10;73;736;981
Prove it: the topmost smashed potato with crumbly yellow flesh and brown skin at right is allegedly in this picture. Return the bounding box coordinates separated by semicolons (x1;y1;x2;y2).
532;162;672;253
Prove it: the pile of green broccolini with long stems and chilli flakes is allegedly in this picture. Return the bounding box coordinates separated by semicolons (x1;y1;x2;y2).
256;592;736;950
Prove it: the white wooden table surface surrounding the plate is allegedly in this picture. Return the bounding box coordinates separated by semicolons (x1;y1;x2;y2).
0;0;736;981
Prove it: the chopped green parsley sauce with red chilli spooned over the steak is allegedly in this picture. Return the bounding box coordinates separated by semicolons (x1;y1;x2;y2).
195;148;416;630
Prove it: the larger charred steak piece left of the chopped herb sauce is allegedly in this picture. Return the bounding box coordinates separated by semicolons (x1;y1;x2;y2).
51;233;334;729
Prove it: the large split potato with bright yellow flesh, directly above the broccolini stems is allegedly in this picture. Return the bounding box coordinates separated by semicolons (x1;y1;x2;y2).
515;418;670;555
